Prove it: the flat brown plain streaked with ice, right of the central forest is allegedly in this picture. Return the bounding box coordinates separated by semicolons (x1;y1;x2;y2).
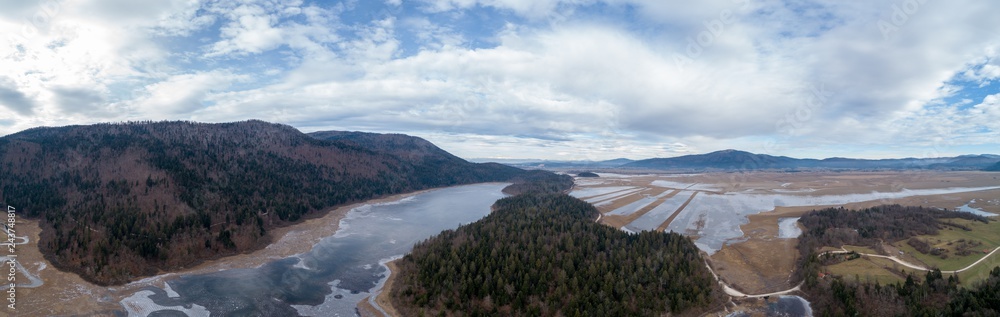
571;171;1000;294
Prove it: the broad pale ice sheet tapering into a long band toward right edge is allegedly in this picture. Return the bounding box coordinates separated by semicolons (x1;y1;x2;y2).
667;186;1000;254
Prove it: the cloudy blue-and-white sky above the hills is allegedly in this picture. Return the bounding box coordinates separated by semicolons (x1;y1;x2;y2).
0;0;1000;160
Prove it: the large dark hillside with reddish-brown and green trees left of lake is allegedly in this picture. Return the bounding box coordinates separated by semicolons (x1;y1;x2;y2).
0;121;528;284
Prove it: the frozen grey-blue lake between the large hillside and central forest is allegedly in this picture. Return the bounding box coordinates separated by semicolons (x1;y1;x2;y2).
122;184;506;316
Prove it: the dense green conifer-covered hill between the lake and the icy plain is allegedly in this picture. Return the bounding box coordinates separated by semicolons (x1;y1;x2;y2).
390;191;722;316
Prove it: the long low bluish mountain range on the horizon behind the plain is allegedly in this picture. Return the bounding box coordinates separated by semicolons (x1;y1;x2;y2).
622;150;1000;170
